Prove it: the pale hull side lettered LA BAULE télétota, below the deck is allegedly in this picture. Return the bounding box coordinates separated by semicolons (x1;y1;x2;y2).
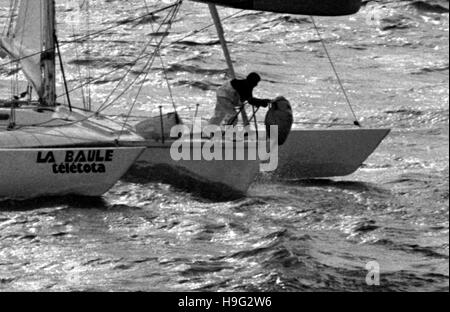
0;147;143;199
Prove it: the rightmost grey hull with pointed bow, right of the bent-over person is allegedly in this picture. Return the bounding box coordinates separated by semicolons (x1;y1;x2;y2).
268;129;390;179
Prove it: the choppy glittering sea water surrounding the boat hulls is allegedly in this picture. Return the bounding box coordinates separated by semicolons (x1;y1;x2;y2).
0;0;449;291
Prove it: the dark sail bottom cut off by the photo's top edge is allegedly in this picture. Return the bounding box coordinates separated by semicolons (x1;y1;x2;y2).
192;0;361;16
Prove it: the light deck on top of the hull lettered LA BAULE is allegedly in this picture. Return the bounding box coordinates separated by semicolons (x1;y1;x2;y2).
0;105;143;149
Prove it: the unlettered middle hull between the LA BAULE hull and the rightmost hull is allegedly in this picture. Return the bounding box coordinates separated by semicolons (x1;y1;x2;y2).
130;139;259;197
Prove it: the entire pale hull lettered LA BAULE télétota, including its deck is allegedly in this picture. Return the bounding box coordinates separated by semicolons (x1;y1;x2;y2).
0;106;144;200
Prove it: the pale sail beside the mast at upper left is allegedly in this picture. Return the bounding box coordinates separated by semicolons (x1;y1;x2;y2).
0;0;46;97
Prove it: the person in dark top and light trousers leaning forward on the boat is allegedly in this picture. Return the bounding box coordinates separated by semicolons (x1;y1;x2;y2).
209;73;272;126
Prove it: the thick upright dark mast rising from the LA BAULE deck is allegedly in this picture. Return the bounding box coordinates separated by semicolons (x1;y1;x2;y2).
41;0;56;106
